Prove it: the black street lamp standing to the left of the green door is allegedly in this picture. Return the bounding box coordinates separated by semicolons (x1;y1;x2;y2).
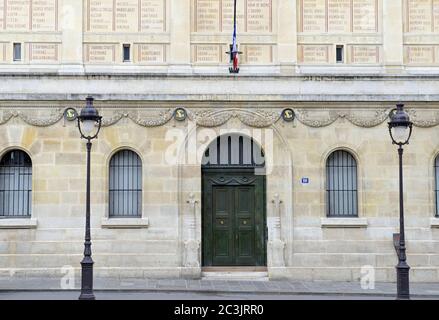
78;96;102;300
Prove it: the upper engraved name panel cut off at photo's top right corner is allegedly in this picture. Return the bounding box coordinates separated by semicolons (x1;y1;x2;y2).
405;0;439;33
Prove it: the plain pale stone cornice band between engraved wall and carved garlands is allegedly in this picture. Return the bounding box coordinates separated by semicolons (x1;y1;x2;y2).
0;75;439;103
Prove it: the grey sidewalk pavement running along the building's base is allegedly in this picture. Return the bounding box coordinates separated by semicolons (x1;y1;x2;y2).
0;278;439;299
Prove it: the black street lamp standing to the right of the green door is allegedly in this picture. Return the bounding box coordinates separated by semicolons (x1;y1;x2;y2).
389;103;413;299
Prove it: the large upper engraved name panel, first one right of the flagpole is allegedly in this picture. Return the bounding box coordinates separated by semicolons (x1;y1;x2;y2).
299;0;379;33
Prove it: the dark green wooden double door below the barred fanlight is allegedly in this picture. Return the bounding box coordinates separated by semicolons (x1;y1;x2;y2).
202;168;266;266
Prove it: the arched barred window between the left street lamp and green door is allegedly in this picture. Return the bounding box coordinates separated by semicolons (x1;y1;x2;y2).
109;150;142;217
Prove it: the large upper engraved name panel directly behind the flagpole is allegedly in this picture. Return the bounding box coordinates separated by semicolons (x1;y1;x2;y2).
192;0;273;33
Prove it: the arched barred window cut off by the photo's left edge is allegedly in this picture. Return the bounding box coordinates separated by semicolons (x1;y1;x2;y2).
0;150;32;218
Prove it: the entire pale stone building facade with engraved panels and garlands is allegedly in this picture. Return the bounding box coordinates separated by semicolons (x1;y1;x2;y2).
0;0;439;282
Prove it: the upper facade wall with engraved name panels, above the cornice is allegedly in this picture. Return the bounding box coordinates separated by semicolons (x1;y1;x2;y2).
0;0;439;74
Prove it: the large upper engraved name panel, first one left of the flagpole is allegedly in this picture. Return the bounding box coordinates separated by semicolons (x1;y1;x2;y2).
86;0;166;33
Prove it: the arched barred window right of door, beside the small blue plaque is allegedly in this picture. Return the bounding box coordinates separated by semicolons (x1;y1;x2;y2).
326;150;358;217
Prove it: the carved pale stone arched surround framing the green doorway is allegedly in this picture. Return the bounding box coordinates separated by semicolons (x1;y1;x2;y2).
178;109;294;279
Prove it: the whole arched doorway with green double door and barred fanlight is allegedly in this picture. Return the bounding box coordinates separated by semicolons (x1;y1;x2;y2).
202;134;267;267
